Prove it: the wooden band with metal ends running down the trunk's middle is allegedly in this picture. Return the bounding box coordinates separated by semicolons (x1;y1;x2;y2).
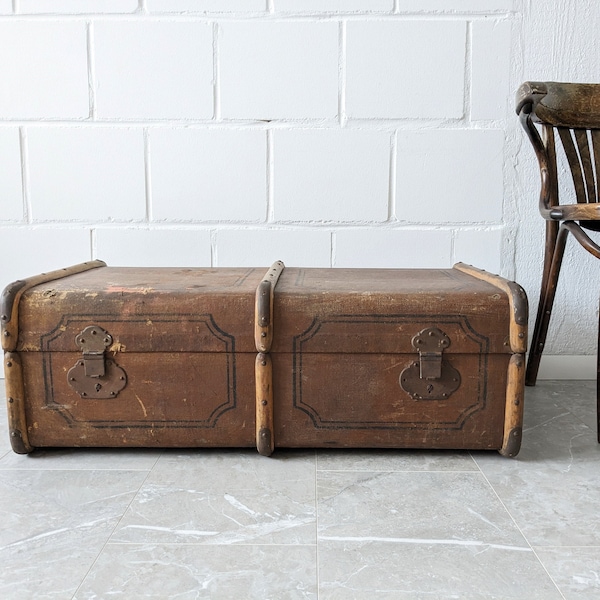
254;261;285;456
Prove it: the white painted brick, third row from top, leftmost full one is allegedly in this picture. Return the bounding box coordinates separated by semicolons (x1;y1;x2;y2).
25;127;146;222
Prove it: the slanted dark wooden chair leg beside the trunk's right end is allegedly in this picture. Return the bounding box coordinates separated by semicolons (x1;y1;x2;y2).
525;221;569;385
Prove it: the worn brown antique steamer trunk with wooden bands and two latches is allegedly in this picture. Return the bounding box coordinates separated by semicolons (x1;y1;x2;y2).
1;261;527;456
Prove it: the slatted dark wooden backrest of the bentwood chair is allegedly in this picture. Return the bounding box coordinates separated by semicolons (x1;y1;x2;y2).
516;82;600;230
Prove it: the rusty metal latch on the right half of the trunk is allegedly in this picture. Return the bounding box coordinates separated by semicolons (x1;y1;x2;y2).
400;327;460;400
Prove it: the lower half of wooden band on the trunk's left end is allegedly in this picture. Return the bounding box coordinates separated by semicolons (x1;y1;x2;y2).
4;352;33;454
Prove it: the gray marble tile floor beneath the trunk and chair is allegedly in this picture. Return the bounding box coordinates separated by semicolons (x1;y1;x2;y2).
0;381;600;600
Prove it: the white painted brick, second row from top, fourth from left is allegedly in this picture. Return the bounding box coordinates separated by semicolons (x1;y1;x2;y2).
346;21;467;119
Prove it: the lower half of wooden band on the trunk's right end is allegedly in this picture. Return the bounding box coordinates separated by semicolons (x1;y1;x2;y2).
499;354;525;457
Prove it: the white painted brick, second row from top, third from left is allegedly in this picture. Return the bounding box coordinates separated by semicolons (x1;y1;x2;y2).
219;21;339;120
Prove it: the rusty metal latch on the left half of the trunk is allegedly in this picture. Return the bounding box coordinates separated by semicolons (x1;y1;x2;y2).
67;325;127;398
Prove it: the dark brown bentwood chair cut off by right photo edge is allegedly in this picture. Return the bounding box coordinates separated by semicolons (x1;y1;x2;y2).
517;82;600;441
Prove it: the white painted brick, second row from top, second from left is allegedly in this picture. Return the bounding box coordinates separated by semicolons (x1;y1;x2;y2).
93;21;214;120
